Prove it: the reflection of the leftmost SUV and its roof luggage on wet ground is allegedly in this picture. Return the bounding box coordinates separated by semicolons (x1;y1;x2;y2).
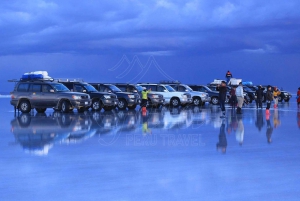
11;112;95;155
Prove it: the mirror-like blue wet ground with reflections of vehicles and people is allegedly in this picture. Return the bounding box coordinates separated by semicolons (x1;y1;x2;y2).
0;98;300;201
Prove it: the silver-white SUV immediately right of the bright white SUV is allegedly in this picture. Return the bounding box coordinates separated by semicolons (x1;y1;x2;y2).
163;83;210;106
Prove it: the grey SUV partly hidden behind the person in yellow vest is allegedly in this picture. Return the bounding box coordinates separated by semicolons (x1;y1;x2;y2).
114;83;165;108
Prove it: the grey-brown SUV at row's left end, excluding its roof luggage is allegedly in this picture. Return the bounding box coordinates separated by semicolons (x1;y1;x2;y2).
10;80;91;113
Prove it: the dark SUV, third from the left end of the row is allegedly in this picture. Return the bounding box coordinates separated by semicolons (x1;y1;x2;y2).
90;83;141;110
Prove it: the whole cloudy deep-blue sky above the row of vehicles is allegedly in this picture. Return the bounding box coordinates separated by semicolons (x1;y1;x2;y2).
0;0;300;92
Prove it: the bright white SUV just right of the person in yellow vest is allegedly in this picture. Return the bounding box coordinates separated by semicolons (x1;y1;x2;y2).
138;83;193;107
